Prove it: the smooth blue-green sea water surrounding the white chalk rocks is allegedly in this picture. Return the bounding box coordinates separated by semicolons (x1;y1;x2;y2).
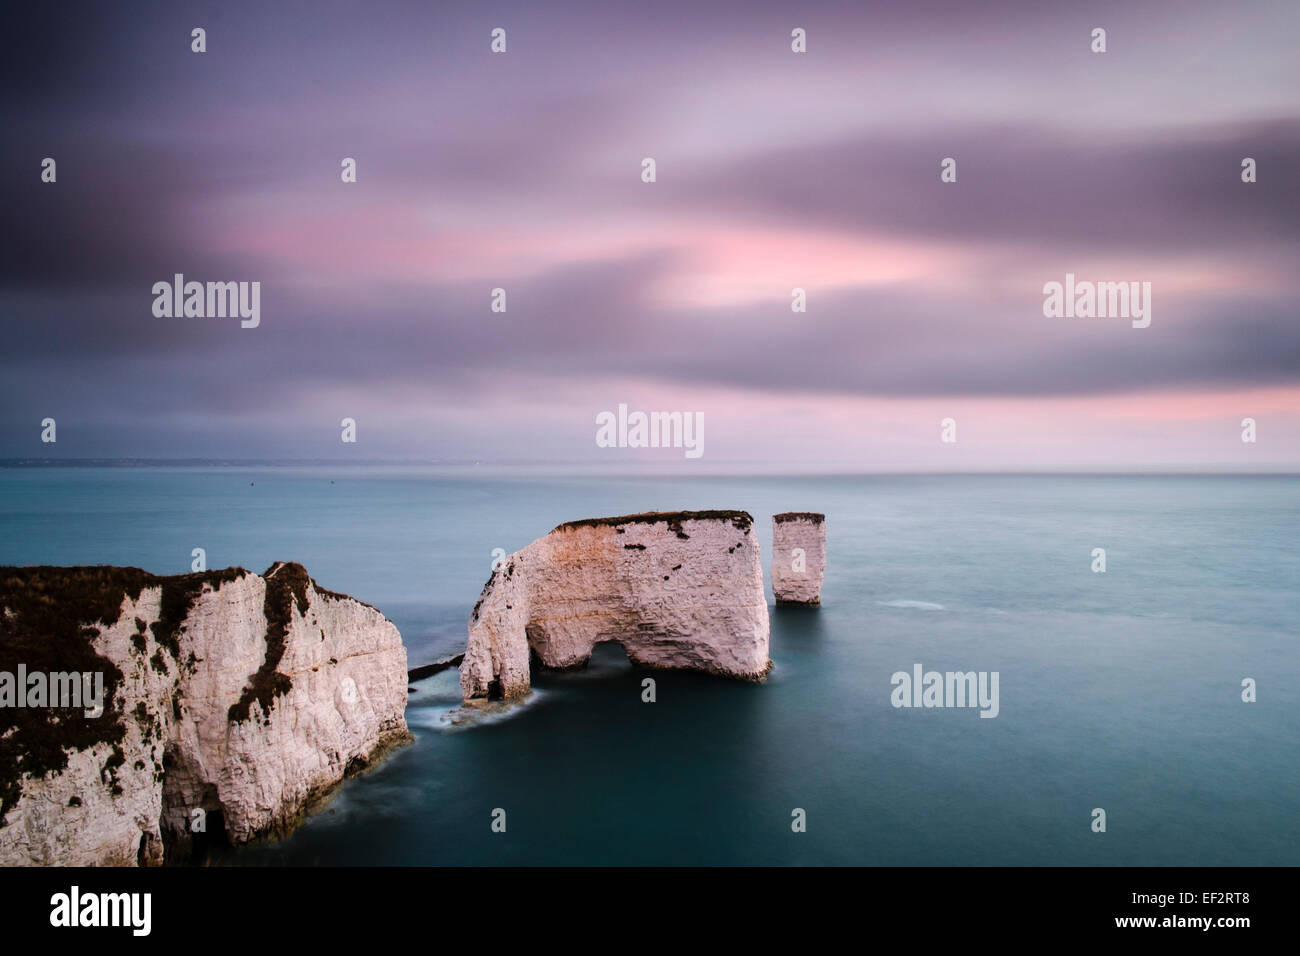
0;467;1300;865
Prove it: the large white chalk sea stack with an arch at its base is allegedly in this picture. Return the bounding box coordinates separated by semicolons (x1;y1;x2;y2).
460;511;772;701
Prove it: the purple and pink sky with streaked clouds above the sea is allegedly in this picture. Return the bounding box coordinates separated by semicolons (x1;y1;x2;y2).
0;0;1300;471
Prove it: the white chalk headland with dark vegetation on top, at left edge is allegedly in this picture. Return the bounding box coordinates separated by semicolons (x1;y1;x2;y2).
0;563;410;866
